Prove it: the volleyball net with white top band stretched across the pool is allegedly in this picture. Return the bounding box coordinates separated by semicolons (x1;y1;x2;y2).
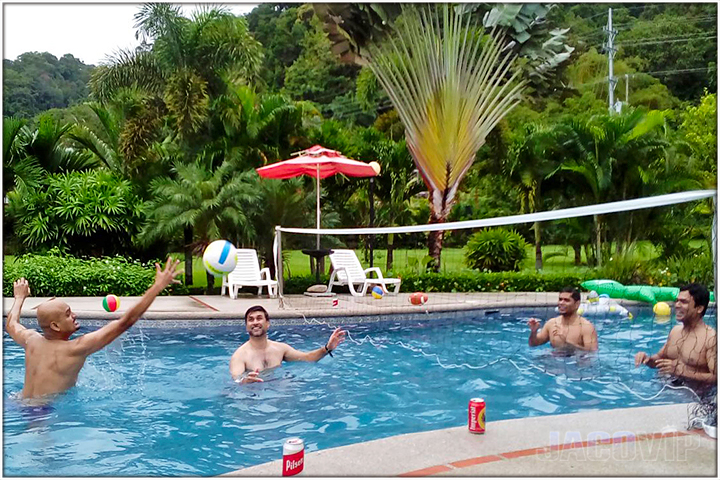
274;190;717;424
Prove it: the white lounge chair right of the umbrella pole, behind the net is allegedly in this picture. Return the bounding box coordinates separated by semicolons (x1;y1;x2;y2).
328;249;400;297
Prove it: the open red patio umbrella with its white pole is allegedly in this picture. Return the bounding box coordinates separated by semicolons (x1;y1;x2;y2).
257;145;380;250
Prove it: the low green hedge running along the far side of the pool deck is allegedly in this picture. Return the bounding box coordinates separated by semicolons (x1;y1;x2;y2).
3;250;713;297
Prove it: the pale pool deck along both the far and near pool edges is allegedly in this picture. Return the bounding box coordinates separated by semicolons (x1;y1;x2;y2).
4;292;717;477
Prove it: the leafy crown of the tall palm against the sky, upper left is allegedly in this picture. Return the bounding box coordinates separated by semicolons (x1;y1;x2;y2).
90;3;262;150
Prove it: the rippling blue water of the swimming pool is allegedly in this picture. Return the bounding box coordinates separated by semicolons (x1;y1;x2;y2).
3;313;715;476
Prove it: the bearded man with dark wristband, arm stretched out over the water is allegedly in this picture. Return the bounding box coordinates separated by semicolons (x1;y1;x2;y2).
230;305;347;383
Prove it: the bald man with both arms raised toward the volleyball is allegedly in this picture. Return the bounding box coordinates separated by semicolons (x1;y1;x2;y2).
5;258;181;400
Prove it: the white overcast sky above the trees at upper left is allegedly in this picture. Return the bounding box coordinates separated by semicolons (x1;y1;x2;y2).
3;3;257;65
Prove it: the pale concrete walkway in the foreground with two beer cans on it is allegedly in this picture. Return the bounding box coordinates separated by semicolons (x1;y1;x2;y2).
227;405;717;477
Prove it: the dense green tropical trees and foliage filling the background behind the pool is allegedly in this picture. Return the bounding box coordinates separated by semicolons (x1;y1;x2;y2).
3;4;717;291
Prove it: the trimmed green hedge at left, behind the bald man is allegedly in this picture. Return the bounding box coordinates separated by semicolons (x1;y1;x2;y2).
3;251;188;297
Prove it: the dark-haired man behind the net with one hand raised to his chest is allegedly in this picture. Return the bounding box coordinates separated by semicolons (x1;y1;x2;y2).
528;287;597;351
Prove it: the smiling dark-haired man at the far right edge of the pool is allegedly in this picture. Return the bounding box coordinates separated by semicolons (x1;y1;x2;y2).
635;283;717;384
